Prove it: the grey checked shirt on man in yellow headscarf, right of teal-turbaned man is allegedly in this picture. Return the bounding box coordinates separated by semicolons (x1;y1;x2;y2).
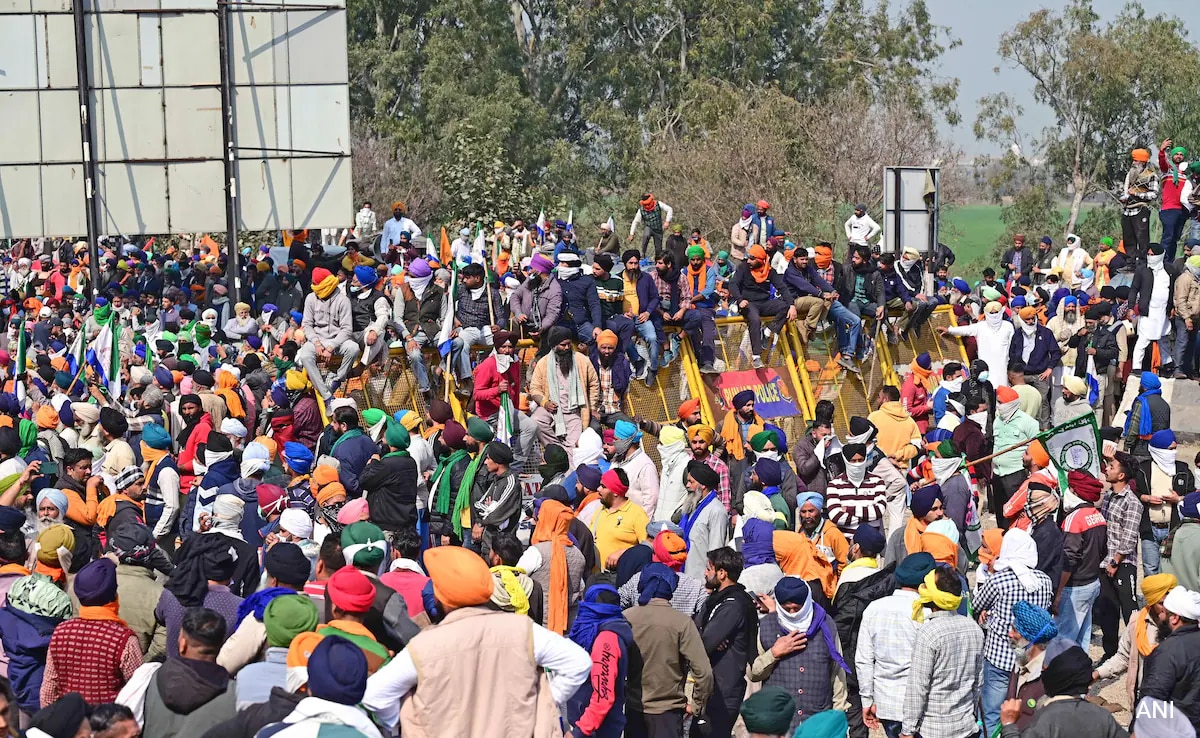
902;611;983;738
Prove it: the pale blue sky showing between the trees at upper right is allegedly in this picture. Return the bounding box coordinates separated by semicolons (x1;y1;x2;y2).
926;0;1196;157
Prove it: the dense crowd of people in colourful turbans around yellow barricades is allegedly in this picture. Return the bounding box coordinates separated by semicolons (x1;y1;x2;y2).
7;153;1200;738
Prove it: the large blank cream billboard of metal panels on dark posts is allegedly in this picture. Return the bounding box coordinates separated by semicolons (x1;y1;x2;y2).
0;0;353;289
